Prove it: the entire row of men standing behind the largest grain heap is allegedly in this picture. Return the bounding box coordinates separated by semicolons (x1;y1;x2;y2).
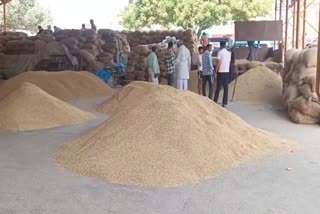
147;36;231;107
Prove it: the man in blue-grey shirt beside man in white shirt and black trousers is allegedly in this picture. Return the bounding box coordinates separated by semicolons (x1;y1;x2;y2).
202;44;214;100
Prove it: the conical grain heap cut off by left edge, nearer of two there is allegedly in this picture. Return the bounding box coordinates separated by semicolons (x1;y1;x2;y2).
0;83;95;131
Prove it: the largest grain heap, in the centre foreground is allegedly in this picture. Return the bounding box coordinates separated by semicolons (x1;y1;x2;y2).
58;82;290;186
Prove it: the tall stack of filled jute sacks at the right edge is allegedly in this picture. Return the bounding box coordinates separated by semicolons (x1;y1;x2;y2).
282;48;320;124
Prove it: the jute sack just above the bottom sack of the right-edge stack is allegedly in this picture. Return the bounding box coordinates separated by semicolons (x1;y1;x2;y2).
289;96;320;118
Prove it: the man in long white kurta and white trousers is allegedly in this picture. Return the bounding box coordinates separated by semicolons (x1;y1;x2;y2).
175;40;191;91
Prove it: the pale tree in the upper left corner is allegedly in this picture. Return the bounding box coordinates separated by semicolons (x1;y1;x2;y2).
0;0;52;33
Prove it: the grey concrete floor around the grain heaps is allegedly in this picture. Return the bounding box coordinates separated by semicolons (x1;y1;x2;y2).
0;99;320;214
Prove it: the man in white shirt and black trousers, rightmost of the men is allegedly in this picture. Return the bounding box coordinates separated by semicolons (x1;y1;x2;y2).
214;41;231;107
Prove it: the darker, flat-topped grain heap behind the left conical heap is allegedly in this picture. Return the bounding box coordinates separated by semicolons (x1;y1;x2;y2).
0;71;113;101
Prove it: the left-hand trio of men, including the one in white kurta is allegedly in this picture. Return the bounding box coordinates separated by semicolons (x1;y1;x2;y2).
147;41;191;91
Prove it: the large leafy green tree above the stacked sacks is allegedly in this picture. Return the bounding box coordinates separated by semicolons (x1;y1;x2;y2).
122;0;273;32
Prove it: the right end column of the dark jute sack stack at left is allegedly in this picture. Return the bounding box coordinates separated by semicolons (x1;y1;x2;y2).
98;29;130;65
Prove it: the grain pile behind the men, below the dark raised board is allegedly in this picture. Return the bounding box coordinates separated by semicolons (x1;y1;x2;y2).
229;66;282;105
